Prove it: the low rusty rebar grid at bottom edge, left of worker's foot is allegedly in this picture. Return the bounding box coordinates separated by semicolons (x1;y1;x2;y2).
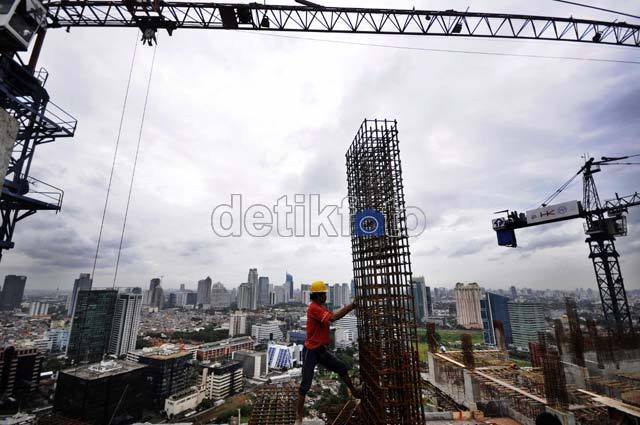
249;385;298;425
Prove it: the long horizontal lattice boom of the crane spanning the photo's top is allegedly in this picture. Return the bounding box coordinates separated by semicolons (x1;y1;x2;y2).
44;0;640;47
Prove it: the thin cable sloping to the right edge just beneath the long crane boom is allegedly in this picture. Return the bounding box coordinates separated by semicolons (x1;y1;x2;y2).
242;31;640;65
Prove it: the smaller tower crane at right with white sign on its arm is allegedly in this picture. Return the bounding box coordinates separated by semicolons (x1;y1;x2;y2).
492;155;640;344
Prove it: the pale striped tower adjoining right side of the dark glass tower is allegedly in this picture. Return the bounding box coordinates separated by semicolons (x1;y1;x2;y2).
108;288;142;357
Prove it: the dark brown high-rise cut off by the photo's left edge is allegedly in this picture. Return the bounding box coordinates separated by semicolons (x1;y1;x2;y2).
0;346;44;406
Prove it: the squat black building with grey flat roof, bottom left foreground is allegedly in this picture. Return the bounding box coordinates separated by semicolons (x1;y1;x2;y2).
53;360;149;425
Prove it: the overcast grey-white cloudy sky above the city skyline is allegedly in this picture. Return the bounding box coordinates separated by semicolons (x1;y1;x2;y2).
2;0;640;289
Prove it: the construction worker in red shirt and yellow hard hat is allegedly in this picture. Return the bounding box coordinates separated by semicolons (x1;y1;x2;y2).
295;280;360;425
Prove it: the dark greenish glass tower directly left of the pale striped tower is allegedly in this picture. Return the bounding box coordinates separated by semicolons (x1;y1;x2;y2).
67;289;118;364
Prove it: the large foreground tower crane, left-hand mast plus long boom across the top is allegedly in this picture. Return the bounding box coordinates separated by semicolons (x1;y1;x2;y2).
0;0;640;258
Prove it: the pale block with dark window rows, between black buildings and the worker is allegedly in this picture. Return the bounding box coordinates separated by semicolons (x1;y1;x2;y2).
198;361;244;401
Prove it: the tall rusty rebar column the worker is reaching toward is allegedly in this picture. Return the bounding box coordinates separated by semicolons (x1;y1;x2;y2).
346;120;423;425
